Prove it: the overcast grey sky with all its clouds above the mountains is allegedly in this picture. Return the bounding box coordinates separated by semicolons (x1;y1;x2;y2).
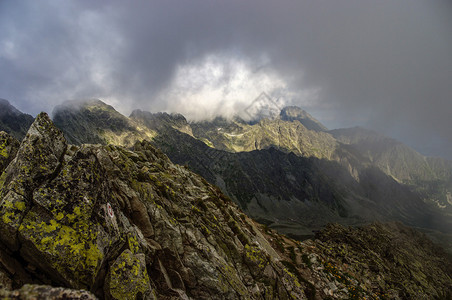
0;0;452;158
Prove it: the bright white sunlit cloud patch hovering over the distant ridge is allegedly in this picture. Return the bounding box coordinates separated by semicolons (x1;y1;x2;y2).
157;55;318;120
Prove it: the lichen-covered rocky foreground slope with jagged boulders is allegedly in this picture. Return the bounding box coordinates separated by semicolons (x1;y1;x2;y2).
0;113;452;299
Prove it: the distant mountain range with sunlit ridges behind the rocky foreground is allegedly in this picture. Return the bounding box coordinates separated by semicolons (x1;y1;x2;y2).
0;99;452;249
